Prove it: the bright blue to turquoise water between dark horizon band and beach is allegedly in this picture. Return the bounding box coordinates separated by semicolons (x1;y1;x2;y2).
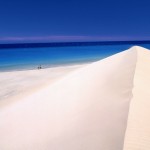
0;44;150;72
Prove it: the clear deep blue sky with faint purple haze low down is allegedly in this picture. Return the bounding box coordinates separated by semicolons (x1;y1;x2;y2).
0;0;150;43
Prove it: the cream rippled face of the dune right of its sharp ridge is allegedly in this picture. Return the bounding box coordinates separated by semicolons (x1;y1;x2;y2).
124;47;150;150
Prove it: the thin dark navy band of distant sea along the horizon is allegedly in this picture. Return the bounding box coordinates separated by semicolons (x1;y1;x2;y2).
0;40;150;49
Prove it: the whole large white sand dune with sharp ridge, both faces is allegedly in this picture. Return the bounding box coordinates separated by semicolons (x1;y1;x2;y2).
0;47;150;150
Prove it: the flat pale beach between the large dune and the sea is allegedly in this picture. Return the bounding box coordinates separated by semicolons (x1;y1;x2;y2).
0;64;87;106
